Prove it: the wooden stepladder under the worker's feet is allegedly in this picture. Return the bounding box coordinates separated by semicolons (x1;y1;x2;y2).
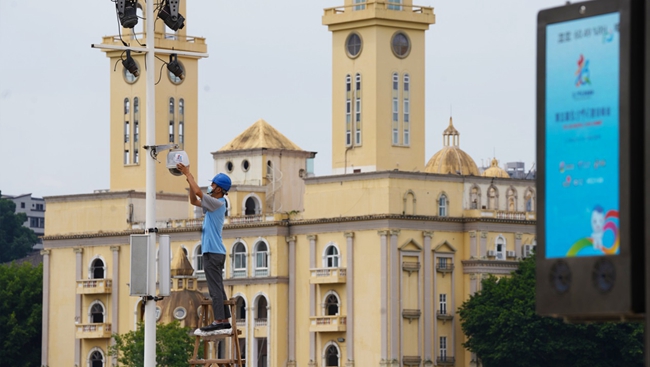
189;298;245;367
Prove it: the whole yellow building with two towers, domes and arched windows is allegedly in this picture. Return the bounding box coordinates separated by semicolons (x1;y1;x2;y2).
42;0;536;367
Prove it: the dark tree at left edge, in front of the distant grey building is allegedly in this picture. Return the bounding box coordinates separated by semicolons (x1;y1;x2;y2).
0;191;38;264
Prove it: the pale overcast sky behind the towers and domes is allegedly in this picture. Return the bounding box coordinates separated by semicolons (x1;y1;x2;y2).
0;0;564;197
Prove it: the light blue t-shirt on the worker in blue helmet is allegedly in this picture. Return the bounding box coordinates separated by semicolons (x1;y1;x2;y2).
201;195;226;255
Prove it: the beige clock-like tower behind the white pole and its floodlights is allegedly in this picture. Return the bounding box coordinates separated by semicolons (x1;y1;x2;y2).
102;1;207;193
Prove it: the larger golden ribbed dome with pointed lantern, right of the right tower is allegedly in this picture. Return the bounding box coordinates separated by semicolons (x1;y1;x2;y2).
424;117;478;176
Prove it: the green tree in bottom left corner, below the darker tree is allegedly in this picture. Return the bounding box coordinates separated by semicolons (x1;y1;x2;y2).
0;263;43;367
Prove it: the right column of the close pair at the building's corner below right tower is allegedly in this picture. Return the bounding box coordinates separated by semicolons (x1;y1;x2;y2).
390;230;401;366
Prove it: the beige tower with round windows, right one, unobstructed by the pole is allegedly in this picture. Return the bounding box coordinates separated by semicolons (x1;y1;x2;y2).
323;0;435;174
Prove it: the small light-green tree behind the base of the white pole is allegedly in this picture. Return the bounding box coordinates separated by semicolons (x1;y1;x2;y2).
108;321;194;367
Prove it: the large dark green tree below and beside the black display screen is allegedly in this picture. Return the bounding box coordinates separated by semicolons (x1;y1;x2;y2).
459;257;644;367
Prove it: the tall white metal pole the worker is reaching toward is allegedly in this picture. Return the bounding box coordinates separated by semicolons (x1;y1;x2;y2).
144;1;156;367
